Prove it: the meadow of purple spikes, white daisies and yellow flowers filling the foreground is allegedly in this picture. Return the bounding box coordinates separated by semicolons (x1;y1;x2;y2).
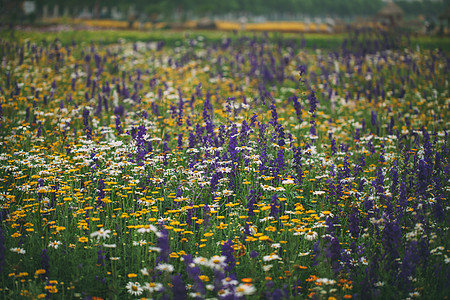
0;29;450;300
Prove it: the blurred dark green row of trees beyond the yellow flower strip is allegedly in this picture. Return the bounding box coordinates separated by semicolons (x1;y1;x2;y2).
0;0;450;20
